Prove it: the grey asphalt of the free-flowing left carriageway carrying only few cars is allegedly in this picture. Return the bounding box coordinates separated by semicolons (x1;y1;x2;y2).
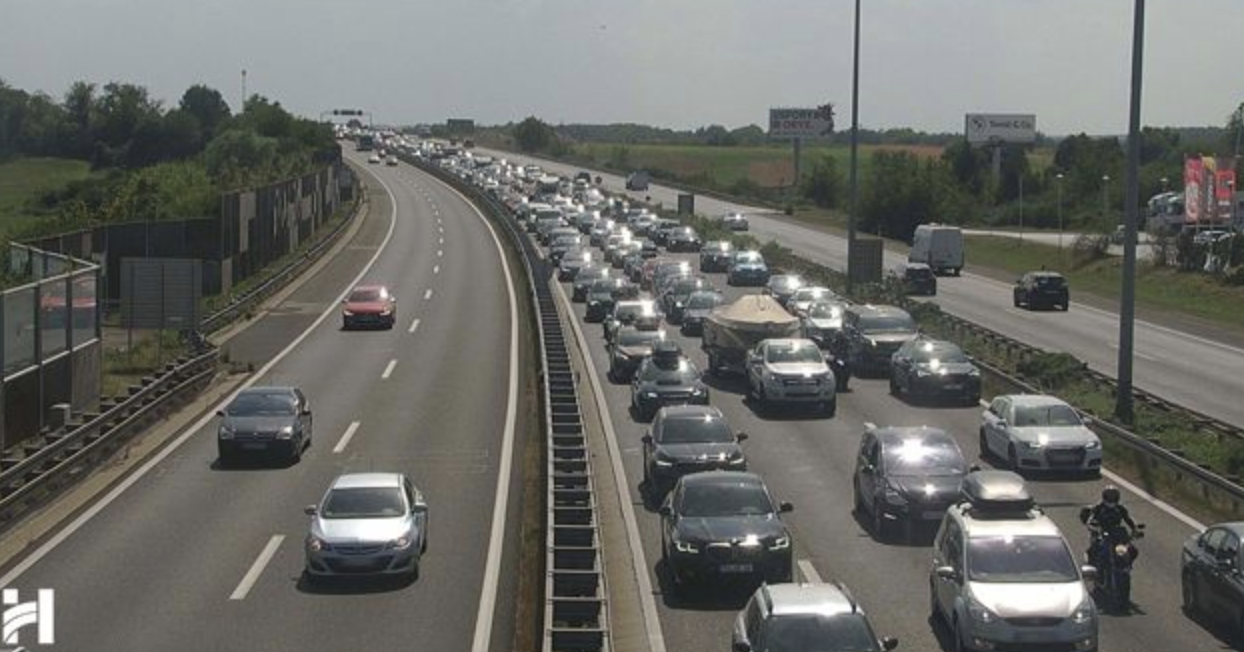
0;152;527;652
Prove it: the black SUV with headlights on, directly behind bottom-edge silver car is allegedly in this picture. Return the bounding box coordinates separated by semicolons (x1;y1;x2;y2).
661;470;794;586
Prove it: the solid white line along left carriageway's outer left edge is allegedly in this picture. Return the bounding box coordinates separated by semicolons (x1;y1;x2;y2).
0;159;397;586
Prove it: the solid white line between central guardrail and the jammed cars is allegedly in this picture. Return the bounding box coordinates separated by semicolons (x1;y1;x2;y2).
555;282;666;652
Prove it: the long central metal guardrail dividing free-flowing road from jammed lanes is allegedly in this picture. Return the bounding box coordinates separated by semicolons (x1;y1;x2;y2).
402;156;612;652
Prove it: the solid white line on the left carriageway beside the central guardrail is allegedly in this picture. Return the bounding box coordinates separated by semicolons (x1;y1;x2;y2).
427;184;519;652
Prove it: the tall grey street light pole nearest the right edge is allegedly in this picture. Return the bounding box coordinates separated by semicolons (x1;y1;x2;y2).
1115;0;1144;424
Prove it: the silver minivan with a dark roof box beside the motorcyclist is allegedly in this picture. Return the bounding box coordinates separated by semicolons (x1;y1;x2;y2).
929;470;1097;652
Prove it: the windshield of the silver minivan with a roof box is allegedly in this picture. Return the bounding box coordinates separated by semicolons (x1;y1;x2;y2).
968;536;1080;584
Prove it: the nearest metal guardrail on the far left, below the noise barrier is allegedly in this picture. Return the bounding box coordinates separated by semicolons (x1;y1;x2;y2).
0;348;216;516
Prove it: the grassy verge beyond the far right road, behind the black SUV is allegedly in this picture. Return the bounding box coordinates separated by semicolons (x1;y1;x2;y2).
964;235;1244;332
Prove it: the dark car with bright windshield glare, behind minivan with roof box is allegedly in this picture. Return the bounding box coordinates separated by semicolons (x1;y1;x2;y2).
852;427;970;541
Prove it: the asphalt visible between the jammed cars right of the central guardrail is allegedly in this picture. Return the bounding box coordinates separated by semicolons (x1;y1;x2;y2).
537;226;1227;652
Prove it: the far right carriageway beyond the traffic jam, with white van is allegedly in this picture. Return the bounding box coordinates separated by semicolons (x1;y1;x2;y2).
483;151;1244;426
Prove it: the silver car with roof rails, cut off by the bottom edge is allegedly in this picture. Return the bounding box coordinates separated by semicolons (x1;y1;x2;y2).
730;582;898;652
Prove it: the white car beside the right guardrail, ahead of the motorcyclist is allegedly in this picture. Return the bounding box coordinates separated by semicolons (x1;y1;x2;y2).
980;394;1101;473
